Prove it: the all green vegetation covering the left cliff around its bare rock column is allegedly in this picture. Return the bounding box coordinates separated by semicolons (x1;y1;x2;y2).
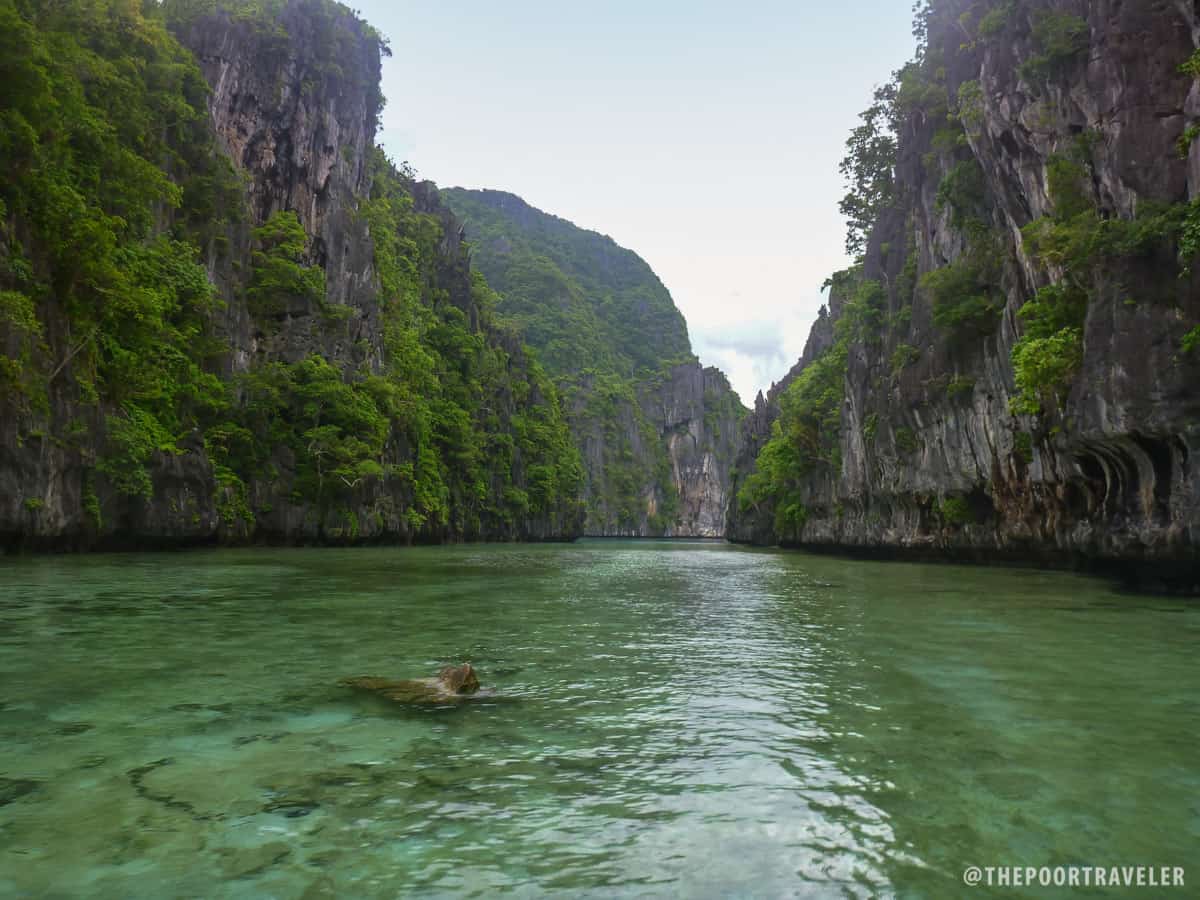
0;0;582;539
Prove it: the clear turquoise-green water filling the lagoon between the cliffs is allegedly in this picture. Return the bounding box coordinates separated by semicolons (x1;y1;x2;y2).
0;541;1200;898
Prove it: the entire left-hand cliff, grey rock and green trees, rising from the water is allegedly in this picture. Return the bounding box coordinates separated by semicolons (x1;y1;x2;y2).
0;0;583;548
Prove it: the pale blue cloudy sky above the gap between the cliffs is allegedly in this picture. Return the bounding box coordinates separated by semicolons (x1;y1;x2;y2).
359;0;913;404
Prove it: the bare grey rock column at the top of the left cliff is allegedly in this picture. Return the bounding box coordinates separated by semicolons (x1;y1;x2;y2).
179;0;381;371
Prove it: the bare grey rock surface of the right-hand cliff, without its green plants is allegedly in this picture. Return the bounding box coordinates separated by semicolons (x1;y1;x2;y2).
728;0;1200;587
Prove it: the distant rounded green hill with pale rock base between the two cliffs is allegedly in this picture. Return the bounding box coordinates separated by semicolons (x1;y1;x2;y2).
443;188;744;538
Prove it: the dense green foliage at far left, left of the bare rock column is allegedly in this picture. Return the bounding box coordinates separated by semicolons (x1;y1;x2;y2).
0;0;240;458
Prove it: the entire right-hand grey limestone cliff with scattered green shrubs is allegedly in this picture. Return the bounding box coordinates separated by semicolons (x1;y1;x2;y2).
730;0;1200;586
